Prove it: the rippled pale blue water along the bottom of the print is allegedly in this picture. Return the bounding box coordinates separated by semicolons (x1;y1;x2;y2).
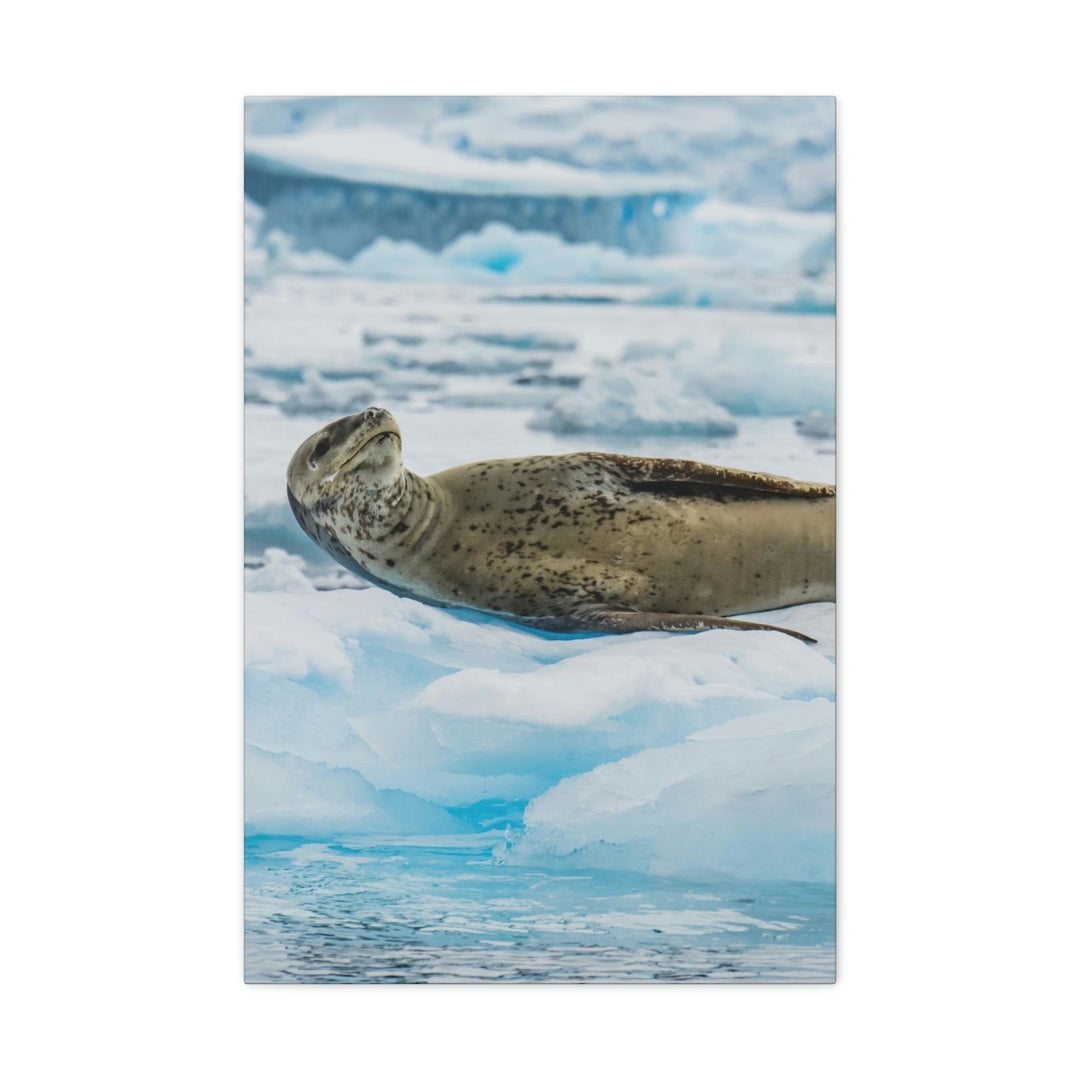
245;833;835;983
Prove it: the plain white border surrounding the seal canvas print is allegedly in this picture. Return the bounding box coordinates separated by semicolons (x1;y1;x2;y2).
3;0;1077;1077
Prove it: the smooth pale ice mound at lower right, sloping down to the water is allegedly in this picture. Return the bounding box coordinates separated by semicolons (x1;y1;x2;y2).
502;700;835;881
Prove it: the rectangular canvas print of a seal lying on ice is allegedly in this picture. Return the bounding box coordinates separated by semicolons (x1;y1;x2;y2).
243;97;836;983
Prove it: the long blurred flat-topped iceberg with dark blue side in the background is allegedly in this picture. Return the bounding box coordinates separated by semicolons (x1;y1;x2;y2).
244;115;835;266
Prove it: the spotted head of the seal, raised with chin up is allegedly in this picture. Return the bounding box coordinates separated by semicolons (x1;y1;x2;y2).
287;408;403;542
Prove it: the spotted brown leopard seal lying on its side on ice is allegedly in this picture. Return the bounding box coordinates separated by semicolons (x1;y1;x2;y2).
287;408;836;642
